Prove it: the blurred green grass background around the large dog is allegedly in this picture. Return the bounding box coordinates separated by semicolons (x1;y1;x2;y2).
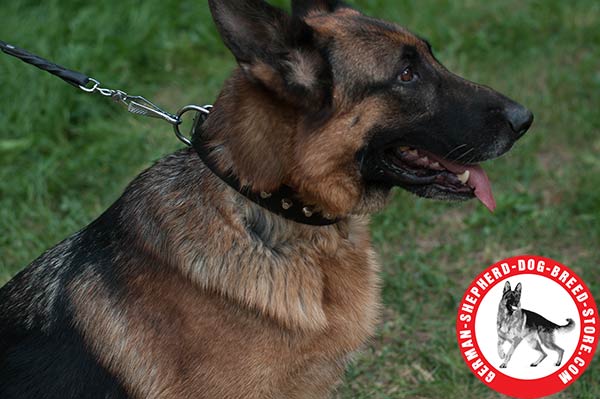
0;0;600;399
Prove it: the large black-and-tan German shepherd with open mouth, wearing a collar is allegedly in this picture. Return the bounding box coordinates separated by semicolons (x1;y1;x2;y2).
0;0;533;399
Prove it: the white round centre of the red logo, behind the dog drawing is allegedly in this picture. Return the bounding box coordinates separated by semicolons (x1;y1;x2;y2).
475;274;581;380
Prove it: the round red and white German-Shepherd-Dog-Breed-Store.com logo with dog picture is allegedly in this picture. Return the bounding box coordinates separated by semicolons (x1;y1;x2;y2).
456;255;600;399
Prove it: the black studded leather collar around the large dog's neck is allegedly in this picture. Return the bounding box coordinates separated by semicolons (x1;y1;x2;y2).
192;116;339;226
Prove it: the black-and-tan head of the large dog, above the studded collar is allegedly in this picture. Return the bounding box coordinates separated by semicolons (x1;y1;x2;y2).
206;0;533;216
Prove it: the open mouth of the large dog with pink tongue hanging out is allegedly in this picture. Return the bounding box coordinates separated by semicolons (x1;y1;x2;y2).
381;146;496;212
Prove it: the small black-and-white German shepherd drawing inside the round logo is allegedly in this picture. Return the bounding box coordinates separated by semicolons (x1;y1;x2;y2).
496;281;575;368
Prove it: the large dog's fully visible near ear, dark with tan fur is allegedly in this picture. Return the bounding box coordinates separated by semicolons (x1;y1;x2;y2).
209;0;327;106
